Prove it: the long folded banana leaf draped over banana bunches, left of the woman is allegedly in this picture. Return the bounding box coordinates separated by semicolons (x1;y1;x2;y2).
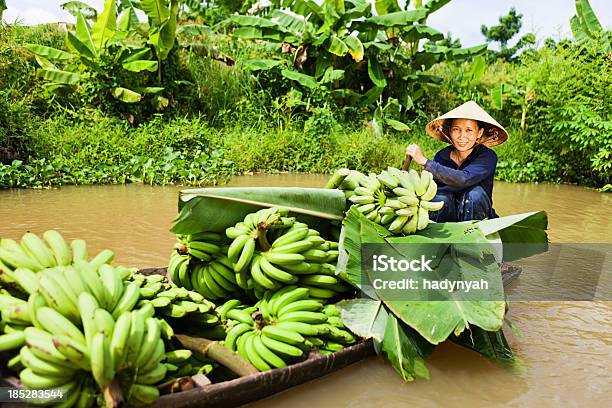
171;187;346;234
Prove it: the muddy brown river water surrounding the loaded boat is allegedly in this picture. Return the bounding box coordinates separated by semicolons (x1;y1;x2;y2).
0;174;612;408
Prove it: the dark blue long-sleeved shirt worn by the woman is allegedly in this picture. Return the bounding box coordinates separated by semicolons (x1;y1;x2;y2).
425;144;497;202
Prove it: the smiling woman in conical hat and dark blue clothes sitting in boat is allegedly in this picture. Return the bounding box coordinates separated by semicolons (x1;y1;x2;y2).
406;101;508;222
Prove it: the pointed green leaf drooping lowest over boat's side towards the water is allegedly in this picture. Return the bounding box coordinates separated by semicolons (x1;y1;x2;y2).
381;314;429;381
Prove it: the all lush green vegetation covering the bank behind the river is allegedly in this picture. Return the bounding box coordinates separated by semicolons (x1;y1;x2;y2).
0;0;612;187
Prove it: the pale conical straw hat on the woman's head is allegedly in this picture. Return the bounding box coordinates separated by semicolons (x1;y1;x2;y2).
425;101;508;147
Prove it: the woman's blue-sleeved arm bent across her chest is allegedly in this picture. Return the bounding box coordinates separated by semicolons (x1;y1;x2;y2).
425;152;497;190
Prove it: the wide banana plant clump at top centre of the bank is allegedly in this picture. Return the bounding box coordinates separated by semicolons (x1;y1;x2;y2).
230;0;486;116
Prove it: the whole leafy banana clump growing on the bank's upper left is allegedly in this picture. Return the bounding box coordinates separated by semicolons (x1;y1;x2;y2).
25;0;178;116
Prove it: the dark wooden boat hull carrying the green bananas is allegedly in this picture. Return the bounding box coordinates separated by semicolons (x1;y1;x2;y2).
0;264;522;408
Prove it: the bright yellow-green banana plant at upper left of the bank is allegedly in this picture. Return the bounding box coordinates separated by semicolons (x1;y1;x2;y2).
25;0;178;103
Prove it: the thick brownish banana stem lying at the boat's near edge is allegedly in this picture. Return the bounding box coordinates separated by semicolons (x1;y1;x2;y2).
176;334;259;377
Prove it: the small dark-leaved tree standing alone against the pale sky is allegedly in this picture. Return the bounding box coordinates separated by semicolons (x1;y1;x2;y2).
480;7;535;61
